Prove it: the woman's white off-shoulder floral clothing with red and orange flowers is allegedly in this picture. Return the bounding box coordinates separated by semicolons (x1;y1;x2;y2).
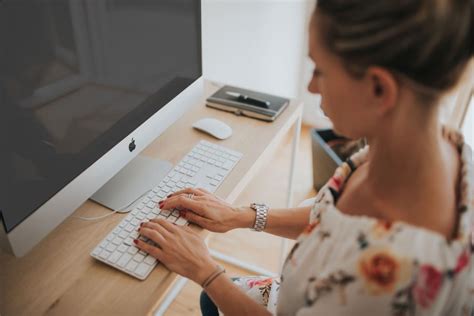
234;129;474;316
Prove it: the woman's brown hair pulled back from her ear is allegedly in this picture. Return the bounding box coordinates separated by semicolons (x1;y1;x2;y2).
314;0;473;99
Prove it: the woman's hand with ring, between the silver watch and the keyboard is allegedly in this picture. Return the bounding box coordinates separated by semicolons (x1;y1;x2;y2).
160;188;255;233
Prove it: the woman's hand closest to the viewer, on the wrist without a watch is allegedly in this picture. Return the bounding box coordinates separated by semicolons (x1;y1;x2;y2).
135;219;216;284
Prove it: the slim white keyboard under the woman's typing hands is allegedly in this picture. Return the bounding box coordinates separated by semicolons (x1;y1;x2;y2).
91;140;242;280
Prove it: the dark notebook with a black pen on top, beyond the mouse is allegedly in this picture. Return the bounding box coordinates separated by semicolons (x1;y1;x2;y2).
206;85;290;122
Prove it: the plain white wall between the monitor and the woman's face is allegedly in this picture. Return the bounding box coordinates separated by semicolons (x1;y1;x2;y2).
202;0;308;97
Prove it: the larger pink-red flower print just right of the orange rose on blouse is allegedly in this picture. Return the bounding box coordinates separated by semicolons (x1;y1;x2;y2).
412;264;443;308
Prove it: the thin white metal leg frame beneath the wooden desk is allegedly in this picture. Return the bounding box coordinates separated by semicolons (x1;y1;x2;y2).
155;114;302;316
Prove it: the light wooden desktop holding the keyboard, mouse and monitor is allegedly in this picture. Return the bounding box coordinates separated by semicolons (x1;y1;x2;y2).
0;84;303;316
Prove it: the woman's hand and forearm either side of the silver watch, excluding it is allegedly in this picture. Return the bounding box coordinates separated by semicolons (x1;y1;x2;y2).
160;188;311;239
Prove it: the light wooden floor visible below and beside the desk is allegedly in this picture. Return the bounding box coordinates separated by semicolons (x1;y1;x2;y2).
165;127;316;316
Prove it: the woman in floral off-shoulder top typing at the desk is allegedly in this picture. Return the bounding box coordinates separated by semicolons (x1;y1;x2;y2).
138;0;474;315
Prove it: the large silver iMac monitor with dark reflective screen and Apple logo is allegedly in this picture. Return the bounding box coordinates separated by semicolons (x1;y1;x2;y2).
0;0;203;256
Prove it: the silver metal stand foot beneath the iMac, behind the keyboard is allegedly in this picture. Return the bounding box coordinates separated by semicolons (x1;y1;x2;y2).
91;155;173;212
